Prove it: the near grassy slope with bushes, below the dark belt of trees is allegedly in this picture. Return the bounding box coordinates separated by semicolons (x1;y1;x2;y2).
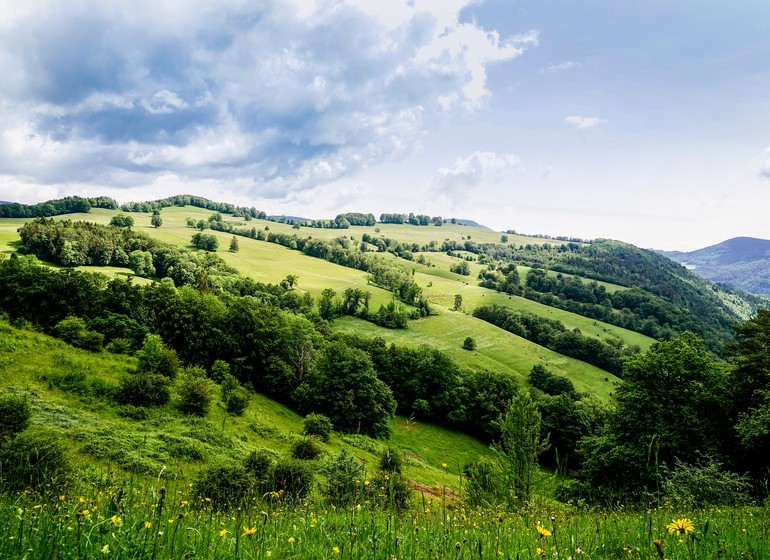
0;321;490;492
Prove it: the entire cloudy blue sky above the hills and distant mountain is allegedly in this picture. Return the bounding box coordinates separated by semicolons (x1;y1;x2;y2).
0;0;770;249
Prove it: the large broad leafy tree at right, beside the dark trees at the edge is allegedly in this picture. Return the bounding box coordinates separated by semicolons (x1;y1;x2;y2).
579;333;730;499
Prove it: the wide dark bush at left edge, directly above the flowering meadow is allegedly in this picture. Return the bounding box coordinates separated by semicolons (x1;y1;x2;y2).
0;432;69;492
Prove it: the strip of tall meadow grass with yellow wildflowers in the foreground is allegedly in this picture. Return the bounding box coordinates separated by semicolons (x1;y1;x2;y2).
0;480;770;559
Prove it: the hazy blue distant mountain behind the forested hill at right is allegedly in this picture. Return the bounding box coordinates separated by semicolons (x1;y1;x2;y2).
657;237;770;296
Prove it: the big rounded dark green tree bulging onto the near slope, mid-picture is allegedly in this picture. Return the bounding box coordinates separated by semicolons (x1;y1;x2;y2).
294;341;396;438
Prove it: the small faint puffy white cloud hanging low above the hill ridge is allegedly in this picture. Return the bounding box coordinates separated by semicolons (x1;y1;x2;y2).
431;151;519;204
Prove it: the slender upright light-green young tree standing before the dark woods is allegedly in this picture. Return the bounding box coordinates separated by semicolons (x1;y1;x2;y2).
497;391;548;506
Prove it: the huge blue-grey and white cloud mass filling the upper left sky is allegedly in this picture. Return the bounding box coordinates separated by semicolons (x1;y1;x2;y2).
0;0;537;206
